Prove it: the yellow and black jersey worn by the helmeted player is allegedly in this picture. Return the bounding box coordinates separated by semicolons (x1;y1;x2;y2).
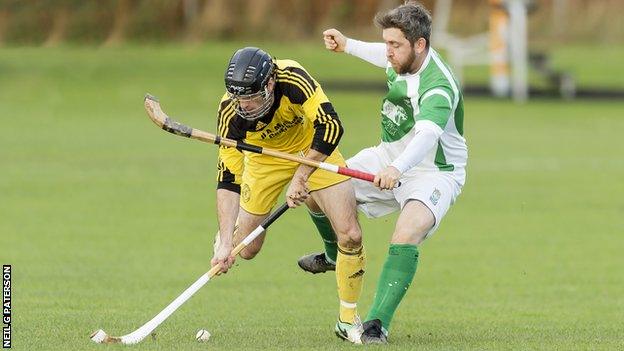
217;60;343;192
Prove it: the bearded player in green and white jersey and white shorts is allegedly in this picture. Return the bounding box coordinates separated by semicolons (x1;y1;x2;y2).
299;2;468;343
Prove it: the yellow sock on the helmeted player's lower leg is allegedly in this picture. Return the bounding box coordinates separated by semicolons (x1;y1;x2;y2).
336;244;366;323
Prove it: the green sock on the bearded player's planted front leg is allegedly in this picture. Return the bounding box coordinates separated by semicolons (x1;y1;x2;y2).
366;244;418;330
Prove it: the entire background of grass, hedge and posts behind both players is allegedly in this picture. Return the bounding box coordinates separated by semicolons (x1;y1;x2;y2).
0;0;624;350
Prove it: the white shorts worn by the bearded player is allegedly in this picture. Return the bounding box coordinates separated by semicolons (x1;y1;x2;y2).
347;147;461;236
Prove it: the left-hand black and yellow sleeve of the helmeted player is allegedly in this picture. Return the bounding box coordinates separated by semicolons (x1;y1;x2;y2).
217;96;244;193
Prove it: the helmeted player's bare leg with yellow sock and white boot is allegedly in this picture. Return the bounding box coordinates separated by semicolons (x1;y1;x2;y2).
312;180;366;342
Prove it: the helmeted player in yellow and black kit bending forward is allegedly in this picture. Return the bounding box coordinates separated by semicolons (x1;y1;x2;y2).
212;47;365;338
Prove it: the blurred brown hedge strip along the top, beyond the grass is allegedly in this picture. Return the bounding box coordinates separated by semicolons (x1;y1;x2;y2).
0;0;624;46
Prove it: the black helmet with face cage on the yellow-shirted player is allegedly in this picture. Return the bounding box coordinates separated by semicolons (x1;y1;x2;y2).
225;47;274;120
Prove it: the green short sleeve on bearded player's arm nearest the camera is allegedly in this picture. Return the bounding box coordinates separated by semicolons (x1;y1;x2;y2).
416;87;453;129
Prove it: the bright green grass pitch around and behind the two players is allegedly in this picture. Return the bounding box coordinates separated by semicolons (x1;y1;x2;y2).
0;44;624;350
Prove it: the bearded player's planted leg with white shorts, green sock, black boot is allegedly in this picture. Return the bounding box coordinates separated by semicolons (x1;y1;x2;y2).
362;177;459;343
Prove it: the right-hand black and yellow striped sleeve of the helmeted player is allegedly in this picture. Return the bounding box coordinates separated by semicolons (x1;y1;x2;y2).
277;67;344;155
